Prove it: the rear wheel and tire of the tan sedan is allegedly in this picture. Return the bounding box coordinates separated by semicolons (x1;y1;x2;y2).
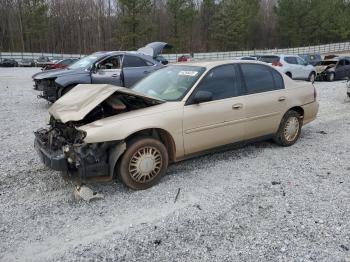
274;110;303;146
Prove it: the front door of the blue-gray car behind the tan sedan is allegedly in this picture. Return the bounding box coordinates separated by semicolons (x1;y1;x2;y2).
91;55;122;86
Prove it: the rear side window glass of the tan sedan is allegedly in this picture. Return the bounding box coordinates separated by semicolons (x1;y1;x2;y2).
241;64;284;95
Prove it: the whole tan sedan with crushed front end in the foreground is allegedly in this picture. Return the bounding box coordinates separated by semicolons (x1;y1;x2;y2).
35;60;318;189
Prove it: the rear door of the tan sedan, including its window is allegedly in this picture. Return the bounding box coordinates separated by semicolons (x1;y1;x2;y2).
240;64;288;139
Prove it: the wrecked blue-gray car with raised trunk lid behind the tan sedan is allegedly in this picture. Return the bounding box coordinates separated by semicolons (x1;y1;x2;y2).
32;42;170;102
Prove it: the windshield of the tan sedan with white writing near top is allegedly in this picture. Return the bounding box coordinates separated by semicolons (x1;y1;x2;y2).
132;65;205;101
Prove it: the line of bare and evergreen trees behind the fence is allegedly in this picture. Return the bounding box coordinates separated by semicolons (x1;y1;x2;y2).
0;0;350;54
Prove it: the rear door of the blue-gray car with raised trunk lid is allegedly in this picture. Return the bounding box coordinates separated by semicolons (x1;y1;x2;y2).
123;54;156;87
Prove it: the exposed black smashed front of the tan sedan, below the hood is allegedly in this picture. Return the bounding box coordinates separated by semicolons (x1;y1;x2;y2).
34;118;119;182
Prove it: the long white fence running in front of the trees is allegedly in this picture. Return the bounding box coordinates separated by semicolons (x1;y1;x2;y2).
0;42;350;62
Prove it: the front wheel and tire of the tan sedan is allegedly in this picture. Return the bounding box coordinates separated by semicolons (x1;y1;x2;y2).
116;137;168;190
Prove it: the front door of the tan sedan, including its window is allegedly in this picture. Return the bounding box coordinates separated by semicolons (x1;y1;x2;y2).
183;65;245;155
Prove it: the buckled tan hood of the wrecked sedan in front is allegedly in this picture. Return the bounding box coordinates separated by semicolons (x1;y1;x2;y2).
49;84;165;123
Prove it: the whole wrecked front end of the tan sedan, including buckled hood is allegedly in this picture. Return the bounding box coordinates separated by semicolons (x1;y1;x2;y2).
34;85;163;182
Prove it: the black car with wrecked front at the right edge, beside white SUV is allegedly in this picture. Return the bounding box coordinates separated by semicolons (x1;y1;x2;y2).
316;57;350;81
